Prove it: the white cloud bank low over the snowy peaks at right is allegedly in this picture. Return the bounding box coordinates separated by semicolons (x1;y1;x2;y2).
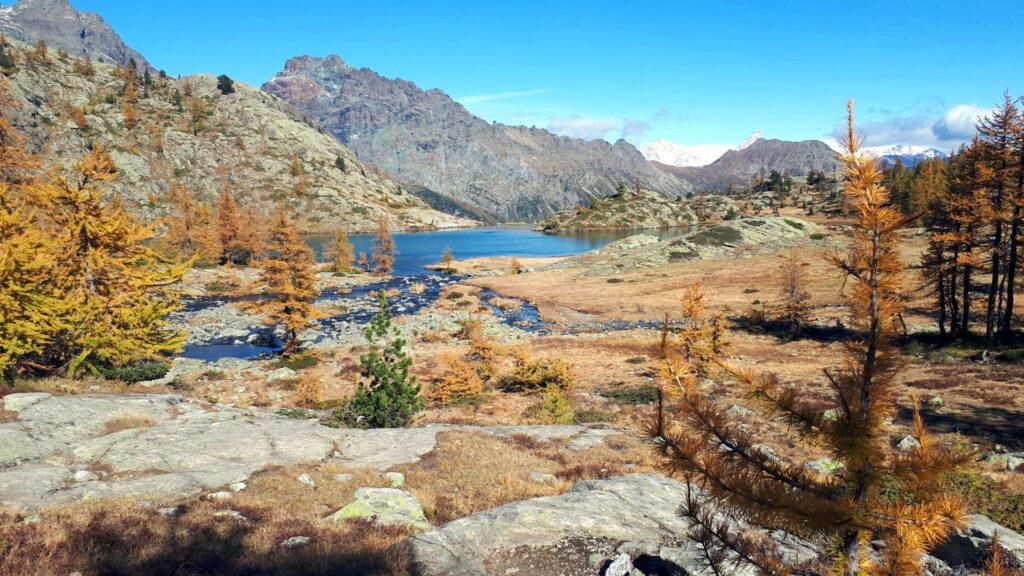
831;104;991;152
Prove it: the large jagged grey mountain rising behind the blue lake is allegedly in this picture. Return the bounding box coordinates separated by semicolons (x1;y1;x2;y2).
263;55;689;220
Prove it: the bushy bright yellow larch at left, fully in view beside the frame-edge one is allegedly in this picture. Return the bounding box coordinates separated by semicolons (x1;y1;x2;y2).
30;145;188;375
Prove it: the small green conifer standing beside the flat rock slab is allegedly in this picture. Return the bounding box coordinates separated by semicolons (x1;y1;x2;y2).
348;291;423;427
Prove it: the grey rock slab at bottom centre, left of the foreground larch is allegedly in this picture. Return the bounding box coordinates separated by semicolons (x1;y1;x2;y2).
399;475;815;576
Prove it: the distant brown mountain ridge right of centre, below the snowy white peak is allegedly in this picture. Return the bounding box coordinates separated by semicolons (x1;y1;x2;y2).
652;138;839;192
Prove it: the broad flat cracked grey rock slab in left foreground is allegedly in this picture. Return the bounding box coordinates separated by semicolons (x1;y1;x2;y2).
0;394;618;507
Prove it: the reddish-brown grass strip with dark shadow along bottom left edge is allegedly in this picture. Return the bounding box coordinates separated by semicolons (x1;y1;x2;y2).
0;507;409;576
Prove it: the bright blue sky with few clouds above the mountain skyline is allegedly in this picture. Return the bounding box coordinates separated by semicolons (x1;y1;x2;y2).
72;0;1024;148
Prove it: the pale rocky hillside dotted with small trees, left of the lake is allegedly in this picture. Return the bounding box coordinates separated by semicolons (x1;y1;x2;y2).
0;41;470;232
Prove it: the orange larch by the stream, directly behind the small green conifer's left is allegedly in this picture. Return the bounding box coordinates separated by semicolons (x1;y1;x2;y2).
255;209;316;353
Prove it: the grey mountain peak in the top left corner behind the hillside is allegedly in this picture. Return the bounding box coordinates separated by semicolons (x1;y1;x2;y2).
0;0;152;68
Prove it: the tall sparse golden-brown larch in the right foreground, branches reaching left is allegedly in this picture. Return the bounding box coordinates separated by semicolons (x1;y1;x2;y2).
648;100;973;576
